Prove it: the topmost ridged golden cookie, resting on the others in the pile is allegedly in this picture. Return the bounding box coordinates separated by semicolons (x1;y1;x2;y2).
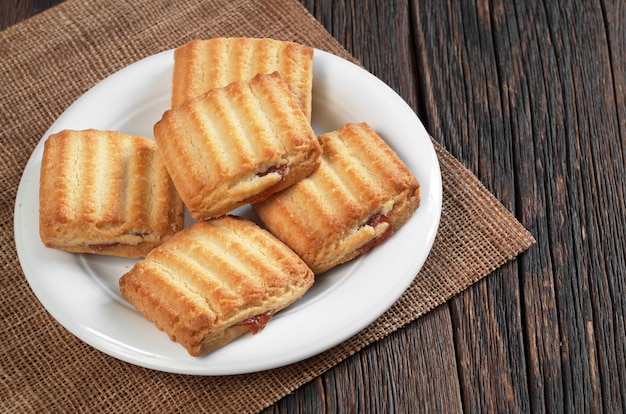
154;72;321;220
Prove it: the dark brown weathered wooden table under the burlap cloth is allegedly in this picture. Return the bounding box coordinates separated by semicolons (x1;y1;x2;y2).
6;0;626;413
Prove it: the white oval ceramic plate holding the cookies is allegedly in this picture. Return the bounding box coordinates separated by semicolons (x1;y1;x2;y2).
15;50;441;375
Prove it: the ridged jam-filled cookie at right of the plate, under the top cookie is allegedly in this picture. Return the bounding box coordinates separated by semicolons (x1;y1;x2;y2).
254;123;420;273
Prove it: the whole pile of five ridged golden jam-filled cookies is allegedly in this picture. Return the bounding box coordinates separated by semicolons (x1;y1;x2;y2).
40;38;420;355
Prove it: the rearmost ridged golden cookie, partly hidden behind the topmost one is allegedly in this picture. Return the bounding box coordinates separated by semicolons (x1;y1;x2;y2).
172;38;314;121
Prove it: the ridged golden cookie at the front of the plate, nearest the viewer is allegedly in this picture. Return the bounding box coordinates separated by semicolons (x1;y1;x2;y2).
120;216;313;355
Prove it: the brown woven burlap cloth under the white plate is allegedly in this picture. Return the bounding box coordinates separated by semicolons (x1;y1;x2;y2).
0;0;534;413
